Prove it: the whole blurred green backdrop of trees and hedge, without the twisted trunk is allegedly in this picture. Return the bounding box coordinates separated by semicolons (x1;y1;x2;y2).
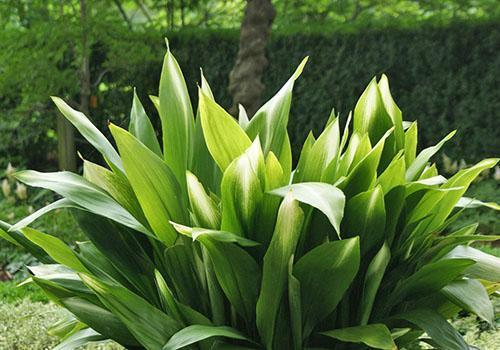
0;0;500;170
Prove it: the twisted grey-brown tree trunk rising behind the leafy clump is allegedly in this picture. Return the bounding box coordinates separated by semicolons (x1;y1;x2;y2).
229;0;276;116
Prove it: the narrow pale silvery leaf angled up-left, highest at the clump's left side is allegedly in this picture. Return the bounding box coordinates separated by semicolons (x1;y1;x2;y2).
51;96;123;171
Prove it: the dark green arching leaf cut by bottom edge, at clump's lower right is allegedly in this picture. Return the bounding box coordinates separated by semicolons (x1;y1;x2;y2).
394;309;469;350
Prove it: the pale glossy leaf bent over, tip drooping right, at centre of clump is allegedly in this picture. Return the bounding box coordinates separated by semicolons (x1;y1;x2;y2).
269;182;345;237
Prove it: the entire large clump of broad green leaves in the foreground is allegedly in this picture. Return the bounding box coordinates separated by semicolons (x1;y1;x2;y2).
0;42;500;350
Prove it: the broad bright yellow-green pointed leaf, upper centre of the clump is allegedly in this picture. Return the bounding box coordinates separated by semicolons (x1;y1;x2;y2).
199;89;252;171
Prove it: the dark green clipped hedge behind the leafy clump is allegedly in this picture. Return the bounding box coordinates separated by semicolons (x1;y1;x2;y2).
0;22;500;170
